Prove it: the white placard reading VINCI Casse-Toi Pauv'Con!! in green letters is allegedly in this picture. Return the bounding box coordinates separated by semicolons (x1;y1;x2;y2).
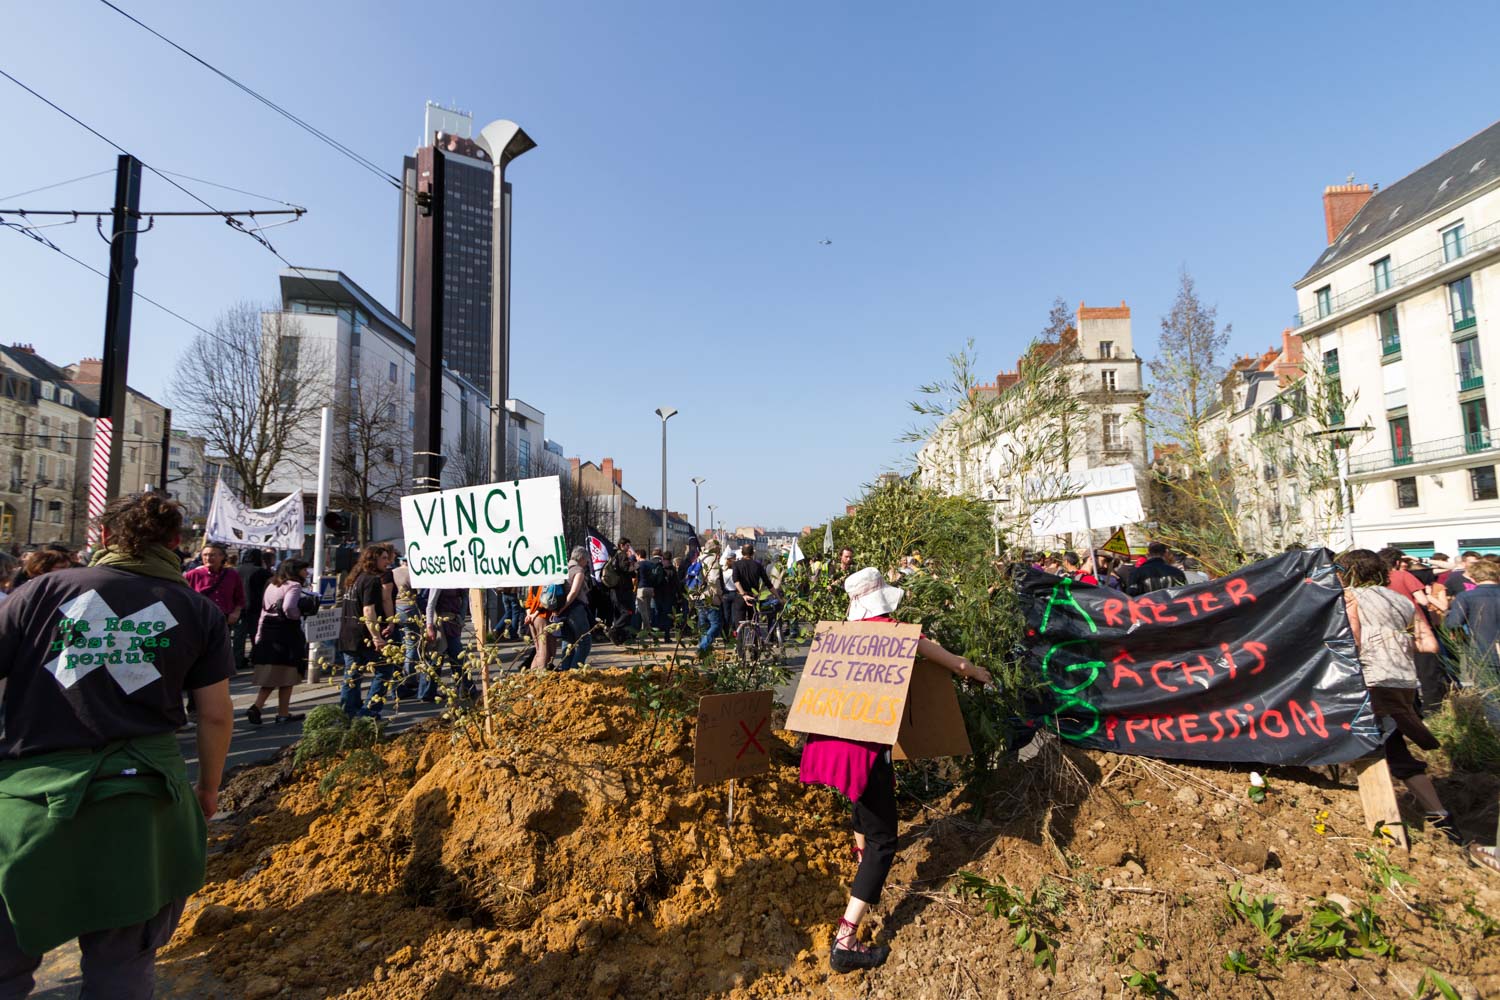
401;475;567;591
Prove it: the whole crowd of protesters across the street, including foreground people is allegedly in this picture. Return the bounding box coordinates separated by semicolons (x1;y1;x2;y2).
0;493;1500;997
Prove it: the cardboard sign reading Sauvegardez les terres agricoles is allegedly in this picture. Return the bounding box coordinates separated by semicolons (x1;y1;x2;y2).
786;622;923;747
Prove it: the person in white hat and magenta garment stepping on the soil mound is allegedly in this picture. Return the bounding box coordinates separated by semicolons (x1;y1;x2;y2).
801;567;992;972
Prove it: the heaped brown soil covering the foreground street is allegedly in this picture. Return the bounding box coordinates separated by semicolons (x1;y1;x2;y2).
161;672;1500;1000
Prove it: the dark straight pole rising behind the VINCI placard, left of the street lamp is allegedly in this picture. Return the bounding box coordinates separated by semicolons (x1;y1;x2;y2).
411;145;446;490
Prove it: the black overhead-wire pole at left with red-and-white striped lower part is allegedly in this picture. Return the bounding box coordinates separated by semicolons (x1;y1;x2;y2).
89;153;141;541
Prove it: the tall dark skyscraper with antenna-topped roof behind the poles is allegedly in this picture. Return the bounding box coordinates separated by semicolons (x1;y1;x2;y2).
396;102;495;394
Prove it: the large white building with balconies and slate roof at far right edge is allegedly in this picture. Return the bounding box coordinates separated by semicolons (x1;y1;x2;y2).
1295;121;1500;553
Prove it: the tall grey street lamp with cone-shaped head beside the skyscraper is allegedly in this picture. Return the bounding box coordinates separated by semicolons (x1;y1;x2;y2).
477;118;537;483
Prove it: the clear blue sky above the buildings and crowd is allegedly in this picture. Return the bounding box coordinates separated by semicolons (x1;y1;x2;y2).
0;0;1500;528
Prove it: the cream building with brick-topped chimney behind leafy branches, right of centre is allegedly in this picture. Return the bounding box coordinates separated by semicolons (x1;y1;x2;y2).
917;301;1151;547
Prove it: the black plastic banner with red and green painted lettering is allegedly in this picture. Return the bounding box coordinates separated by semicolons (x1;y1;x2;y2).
1022;549;1383;765
